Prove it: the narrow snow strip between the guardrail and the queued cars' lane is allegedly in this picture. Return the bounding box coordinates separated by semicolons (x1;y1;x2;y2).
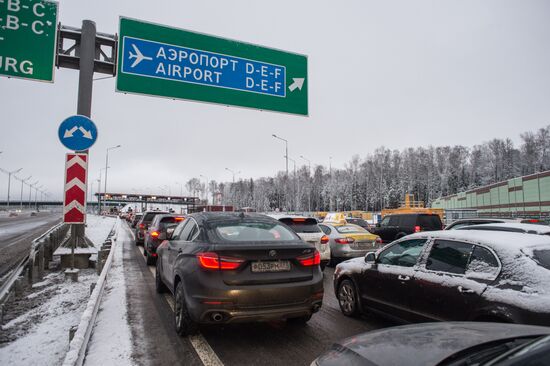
84;221;133;366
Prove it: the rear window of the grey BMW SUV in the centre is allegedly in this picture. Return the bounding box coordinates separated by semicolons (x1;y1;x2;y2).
210;222;300;243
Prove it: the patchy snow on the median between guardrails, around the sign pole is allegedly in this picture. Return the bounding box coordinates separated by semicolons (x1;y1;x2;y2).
0;215;118;366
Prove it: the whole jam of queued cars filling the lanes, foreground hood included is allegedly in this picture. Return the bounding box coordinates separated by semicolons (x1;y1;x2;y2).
125;211;550;365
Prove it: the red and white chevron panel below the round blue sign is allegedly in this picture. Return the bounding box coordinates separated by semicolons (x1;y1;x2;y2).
63;154;88;224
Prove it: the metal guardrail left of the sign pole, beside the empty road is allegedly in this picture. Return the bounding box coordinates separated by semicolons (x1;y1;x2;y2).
0;223;68;305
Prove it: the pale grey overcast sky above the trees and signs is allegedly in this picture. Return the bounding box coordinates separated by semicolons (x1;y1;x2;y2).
0;0;550;199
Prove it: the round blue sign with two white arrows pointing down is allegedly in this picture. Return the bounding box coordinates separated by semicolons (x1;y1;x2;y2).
57;115;97;151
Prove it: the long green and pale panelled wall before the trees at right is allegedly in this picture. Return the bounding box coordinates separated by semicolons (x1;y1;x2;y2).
432;171;550;217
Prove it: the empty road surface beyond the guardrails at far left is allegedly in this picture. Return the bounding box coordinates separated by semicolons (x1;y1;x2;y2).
0;212;61;278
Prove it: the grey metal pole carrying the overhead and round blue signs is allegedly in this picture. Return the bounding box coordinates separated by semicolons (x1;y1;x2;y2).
71;20;96;268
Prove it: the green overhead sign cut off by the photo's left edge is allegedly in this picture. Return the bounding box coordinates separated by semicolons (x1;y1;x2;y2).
0;0;57;82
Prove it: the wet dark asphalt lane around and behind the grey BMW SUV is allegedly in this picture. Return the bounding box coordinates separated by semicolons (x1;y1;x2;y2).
119;225;395;366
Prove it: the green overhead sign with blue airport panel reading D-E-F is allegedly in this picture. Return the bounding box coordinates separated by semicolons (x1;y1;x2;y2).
117;18;308;116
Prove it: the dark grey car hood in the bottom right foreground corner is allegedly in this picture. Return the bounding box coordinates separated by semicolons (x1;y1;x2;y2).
316;322;550;366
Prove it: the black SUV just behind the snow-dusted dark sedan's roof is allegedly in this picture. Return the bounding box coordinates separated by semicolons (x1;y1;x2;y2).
371;213;443;243
